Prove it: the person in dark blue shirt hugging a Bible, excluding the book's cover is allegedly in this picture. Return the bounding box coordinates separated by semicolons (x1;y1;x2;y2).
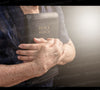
0;6;75;87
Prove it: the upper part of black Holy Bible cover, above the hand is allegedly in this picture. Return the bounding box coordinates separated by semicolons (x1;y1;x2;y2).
24;12;59;43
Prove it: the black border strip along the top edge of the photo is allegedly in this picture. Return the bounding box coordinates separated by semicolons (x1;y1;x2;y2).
0;0;100;5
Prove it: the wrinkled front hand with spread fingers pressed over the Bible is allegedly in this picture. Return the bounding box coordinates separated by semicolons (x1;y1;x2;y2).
16;38;63;76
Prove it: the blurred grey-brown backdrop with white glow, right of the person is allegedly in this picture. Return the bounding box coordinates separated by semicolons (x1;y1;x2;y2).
54;6;100;87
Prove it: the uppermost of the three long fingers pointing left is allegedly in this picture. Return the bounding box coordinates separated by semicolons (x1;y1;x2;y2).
18;44;40;50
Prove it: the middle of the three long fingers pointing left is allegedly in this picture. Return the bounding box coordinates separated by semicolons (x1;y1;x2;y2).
16;50;37;56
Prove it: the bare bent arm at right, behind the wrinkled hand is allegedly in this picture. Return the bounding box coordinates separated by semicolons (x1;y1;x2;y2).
58;40;76;65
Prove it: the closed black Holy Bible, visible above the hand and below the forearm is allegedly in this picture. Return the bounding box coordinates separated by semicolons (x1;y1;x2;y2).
19;12;59;85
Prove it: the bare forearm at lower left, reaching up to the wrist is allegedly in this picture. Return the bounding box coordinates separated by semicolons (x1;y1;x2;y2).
0;62;37;87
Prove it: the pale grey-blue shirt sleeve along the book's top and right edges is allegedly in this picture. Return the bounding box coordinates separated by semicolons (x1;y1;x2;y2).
40;6;69;43
